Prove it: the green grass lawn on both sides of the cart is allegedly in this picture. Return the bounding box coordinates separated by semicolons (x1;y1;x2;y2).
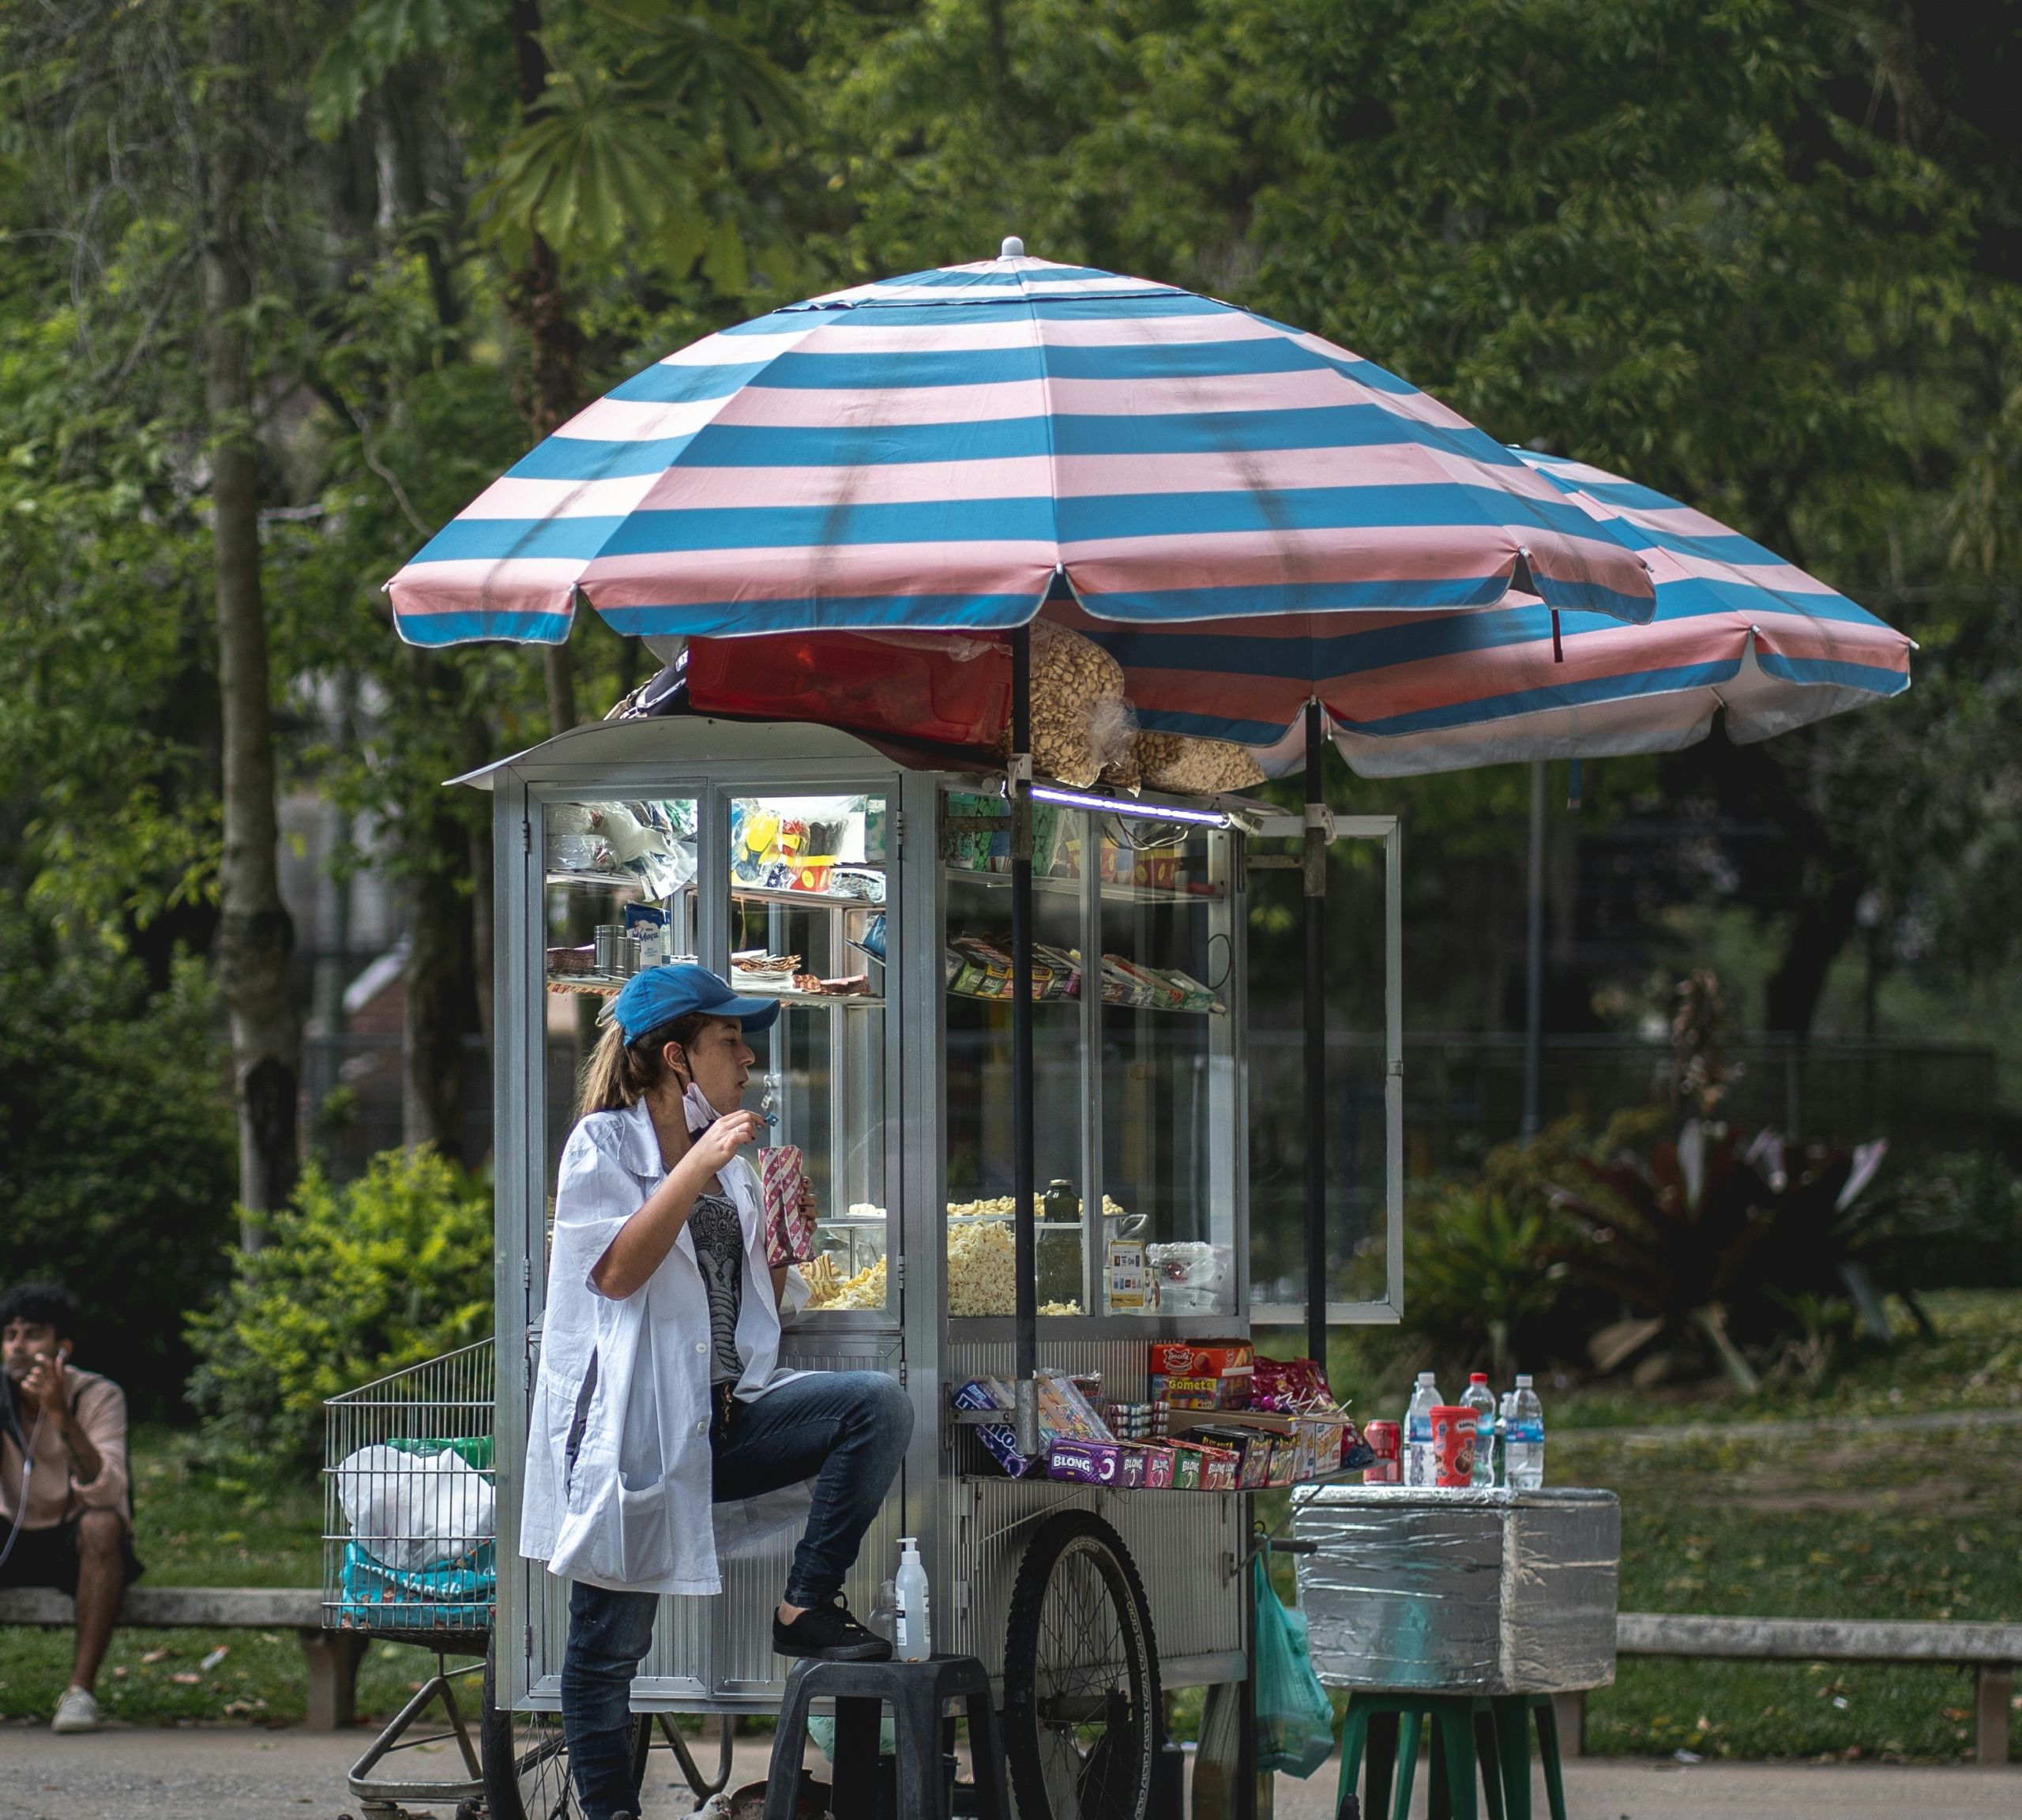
12;1290;2022;1762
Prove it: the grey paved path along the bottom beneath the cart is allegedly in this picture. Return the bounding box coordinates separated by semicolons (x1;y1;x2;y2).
0;1725;2022;1820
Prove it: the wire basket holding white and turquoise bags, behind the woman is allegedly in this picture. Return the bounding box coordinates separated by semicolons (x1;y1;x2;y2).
324;1341;498;1653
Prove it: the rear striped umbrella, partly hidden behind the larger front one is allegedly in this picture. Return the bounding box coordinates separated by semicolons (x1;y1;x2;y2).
1075;451;1911;777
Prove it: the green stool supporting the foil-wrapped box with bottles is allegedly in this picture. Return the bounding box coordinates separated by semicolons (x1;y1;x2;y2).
1335;1689;1565;1820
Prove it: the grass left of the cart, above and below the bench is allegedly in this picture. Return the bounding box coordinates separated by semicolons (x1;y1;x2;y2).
0;1427;477;1725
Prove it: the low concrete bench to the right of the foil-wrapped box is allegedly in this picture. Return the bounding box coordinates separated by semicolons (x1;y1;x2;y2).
1555;1611;2022;1763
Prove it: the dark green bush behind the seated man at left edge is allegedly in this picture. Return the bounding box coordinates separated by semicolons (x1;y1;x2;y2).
0;900;237;1418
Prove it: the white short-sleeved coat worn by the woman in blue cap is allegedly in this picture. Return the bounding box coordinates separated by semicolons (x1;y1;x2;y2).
520;1102;806;1593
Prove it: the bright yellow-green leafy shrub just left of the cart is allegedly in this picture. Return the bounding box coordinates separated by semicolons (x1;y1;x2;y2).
190;1149;491;1470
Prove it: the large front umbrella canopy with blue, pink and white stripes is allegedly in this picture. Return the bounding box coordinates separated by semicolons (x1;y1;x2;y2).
389;243;1652;728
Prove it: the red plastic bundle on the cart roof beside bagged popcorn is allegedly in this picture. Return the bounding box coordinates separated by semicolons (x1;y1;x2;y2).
687;633;1011;746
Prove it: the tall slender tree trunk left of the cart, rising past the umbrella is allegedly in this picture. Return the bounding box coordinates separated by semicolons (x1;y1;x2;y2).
202;8;301;1250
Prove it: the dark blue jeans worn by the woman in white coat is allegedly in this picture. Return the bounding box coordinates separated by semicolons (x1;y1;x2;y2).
562;1371;912;1820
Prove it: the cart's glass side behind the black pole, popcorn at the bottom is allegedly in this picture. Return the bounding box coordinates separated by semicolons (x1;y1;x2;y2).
940;783;1239;1321
